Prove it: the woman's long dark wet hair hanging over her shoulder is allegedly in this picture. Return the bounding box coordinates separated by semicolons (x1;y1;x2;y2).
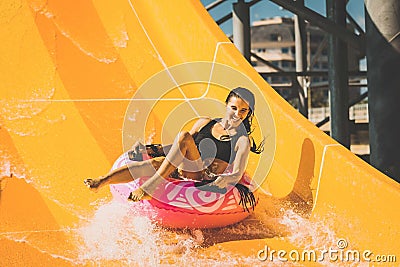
225;87;265;154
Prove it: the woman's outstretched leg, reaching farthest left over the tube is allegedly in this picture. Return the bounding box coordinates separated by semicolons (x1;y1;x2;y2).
84;157;165;192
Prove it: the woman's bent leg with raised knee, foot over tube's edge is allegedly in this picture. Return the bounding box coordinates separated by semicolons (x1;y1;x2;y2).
129;132;203;201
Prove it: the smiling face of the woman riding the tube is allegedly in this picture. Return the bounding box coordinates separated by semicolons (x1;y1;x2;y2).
225;96;250;127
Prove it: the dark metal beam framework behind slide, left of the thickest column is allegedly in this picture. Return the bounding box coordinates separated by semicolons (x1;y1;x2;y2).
212;0;384;165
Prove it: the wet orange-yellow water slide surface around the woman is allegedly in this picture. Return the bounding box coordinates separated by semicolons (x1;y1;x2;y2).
0;0;400;266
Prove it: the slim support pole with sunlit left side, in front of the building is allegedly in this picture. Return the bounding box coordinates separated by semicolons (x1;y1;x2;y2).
294;0;308;118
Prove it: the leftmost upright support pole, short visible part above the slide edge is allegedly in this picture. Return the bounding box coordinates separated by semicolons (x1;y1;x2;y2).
232;0;250;62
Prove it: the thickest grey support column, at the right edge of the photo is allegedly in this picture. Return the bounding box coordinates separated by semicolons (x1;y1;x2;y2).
365;0;400;182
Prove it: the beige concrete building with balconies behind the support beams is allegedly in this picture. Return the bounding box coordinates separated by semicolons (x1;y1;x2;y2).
251;17;369;154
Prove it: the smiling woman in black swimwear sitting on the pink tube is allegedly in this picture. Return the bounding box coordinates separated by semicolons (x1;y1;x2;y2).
85;87;263;205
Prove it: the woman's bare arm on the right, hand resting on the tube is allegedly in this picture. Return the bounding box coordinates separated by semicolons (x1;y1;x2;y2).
213;136;250;188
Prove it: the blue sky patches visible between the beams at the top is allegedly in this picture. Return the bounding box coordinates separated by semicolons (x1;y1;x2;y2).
201;0;365;35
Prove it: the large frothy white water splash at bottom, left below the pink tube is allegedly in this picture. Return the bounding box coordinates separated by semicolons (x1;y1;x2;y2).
80;202;169;266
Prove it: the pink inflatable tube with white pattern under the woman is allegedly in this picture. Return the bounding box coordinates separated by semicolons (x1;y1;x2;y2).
110;153;258;228
